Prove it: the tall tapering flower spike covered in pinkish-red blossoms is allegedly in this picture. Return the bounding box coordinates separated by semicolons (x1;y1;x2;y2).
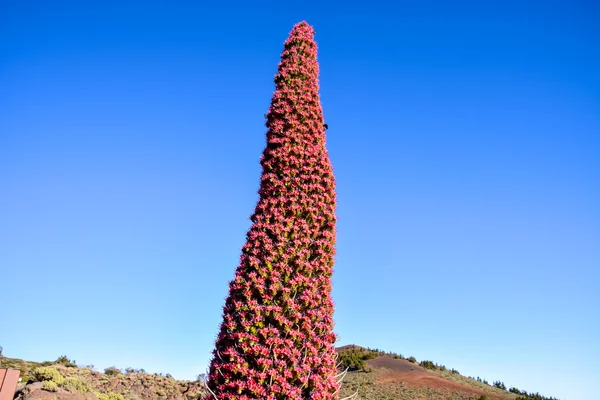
208;22;339;400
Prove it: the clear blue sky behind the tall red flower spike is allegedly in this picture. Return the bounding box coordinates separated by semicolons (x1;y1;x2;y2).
0;0;600;399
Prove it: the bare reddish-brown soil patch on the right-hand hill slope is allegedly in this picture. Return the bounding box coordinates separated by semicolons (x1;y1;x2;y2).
367;355;505;400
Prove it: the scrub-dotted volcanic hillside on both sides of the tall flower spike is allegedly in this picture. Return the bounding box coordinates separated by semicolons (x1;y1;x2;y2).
0;345;556;400
